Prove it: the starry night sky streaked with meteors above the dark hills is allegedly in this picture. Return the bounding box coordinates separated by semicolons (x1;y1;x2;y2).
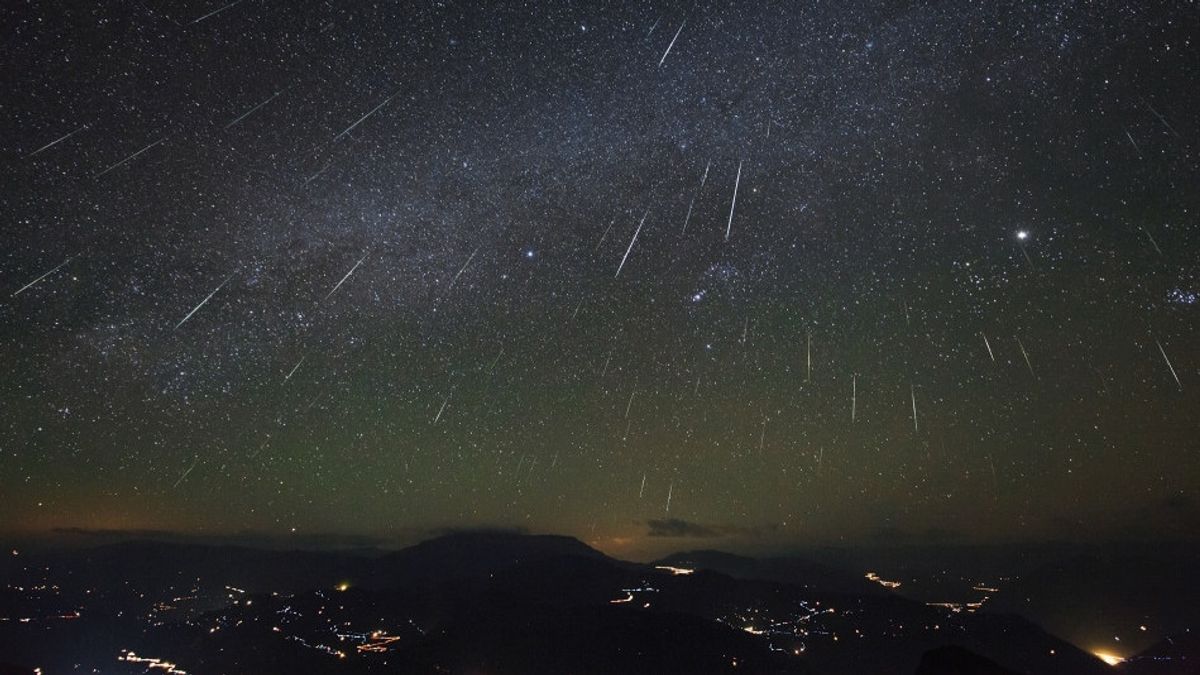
0;0;1200;554
